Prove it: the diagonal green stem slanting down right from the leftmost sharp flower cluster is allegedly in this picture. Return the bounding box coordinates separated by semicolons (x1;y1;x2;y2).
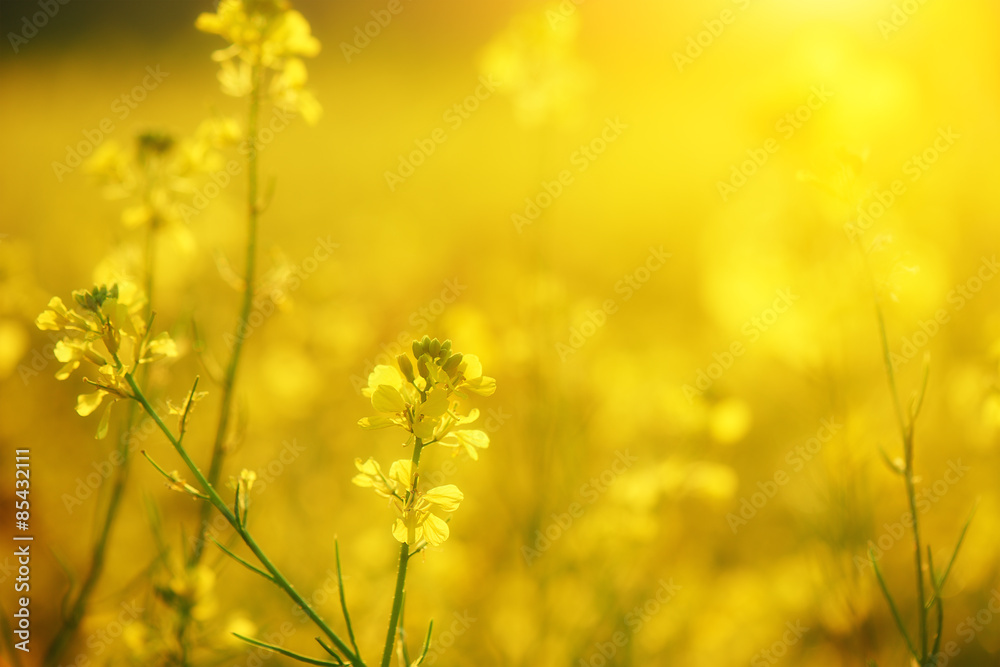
125;373;365;667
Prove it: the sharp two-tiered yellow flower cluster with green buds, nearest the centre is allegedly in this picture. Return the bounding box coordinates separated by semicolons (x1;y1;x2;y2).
353;336;496;546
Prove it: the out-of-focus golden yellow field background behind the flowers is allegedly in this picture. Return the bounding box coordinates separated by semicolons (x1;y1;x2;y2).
0;0;1000;667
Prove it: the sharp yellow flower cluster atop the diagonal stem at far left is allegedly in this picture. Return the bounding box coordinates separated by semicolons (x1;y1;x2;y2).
35;282;177;439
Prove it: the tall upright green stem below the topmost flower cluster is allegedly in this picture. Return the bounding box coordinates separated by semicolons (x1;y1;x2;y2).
189;65;261;565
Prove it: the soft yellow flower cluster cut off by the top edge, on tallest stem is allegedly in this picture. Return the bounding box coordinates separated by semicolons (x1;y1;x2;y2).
195;0;322;124
